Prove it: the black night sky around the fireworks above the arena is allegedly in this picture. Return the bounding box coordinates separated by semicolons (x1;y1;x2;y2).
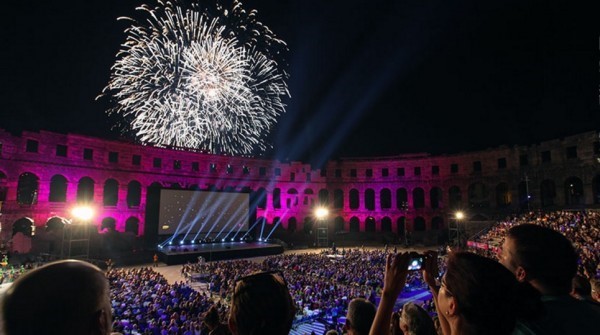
0;0;600;166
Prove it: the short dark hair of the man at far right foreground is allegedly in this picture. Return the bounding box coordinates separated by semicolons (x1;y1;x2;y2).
508;224;577;294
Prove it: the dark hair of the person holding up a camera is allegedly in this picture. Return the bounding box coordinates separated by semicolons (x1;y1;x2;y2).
444;252;518;334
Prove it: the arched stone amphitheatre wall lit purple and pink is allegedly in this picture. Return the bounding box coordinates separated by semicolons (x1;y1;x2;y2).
0;130;600;247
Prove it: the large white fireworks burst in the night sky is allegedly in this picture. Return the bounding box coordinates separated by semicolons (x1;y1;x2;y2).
103;1;289;155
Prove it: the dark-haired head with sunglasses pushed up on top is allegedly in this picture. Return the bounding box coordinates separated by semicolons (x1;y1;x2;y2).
229;272;296;335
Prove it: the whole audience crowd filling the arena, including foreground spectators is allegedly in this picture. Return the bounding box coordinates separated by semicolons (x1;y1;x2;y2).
2;212;600;335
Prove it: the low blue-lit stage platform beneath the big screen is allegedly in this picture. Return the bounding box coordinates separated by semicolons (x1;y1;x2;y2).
158;242;283;265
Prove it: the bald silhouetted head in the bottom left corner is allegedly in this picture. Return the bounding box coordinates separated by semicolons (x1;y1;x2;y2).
2;260;112;335
